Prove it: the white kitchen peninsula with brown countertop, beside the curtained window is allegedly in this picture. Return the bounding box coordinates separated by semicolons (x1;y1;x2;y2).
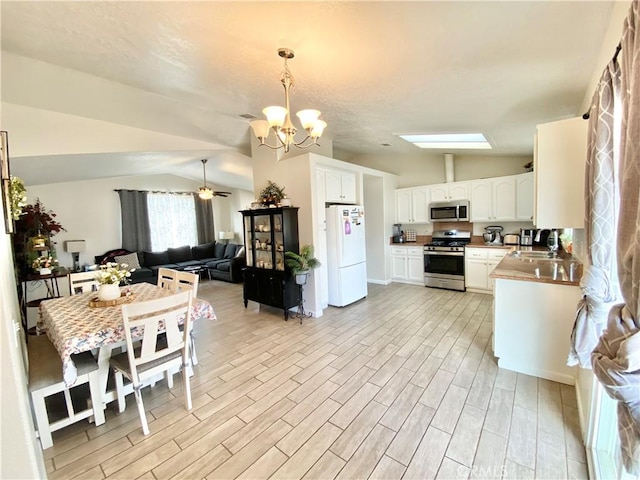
490;251;582;385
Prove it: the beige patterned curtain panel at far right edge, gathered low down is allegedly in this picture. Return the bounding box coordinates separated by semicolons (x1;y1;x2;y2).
591;0;640;475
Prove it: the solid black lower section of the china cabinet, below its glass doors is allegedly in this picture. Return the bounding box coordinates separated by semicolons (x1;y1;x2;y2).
244;267;300;320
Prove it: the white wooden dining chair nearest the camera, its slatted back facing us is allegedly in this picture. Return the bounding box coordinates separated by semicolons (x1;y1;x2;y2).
110;290;193;435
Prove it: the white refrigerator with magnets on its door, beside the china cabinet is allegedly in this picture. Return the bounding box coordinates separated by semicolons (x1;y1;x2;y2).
326;205;367;307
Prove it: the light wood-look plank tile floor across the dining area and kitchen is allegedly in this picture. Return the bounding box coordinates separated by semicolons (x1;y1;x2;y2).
44;281;588;479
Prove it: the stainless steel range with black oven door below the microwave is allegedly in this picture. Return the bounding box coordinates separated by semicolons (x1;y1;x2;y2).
423;230;471;292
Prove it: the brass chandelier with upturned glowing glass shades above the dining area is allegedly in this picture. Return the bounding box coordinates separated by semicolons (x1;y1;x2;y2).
249;48;327;152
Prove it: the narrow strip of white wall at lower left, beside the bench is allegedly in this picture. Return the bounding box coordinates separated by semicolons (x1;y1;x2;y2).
0;201;46;479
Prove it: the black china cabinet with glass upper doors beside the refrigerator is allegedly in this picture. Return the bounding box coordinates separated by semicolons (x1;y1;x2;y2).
241;207;300;320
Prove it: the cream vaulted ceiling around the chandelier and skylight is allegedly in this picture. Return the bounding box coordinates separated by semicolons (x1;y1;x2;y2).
1;1;613;188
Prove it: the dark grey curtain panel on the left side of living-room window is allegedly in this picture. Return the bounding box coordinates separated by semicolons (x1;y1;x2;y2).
117;190;151;252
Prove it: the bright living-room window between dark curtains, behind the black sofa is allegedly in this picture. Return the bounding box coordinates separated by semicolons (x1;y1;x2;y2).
147;193;198;252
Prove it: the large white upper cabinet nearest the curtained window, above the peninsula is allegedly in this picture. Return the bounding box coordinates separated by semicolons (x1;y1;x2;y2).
533;117;589;228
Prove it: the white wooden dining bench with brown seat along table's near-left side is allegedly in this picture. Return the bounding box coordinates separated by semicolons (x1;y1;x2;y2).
27;335;104;450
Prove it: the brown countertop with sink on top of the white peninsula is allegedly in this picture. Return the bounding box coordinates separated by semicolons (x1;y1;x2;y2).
489;252;582;286
